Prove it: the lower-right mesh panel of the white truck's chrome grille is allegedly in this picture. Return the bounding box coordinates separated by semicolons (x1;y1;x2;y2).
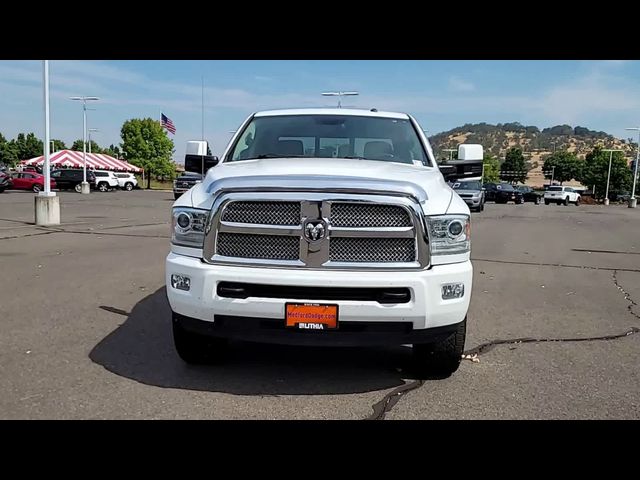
329;237;416;263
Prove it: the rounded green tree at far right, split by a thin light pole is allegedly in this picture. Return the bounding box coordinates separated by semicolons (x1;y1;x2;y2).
578;147;633;198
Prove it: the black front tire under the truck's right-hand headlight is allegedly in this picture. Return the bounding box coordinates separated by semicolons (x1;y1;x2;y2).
413;317;467;378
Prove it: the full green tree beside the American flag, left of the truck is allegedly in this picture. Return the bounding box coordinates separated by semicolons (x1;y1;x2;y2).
120;118;175;188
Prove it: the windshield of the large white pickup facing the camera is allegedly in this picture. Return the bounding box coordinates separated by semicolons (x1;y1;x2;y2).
226;115;430;165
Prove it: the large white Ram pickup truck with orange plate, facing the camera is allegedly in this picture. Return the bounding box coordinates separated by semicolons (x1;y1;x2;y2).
166;109;482;377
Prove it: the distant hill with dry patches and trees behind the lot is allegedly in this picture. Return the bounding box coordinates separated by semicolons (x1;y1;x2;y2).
429;122;635;184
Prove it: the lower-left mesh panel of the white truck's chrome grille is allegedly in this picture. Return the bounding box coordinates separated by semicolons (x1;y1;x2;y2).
217;232;300;260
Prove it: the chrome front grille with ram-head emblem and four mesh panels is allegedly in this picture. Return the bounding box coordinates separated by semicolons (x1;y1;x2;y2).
210;192;428;269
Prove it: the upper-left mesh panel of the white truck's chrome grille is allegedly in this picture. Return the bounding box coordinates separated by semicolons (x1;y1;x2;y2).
222;202;300;225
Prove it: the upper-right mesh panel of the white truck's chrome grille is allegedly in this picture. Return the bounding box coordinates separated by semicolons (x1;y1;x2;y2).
331;203;411;228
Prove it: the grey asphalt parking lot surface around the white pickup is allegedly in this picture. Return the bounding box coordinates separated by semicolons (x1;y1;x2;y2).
0;191;640;420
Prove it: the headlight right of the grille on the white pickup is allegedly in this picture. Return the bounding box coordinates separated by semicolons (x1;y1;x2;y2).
426;215;471;255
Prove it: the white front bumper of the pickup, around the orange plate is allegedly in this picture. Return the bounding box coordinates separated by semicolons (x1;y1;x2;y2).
165;252;473;344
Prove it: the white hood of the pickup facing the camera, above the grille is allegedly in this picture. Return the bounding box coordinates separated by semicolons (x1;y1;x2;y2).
176;158;468;215
